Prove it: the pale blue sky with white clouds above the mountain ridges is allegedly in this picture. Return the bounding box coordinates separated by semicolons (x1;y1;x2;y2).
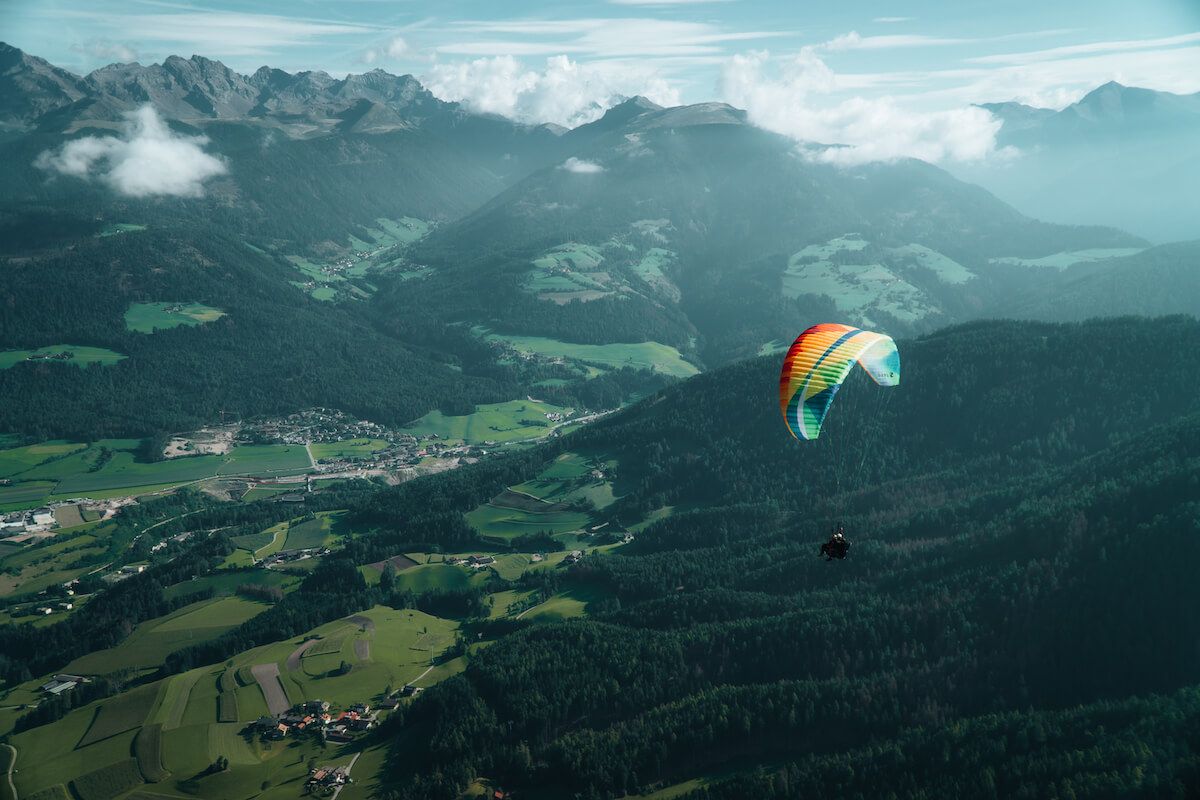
0;0;1200;162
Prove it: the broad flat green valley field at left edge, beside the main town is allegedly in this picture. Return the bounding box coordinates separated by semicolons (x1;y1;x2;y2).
0;439;311;510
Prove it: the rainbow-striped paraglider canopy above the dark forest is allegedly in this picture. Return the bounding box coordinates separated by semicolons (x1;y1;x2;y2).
779;323;900;439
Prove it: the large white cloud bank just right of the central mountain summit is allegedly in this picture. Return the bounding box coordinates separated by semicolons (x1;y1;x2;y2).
721;50;1001;164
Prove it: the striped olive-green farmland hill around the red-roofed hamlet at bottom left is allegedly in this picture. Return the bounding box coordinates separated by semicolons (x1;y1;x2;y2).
13;606;466;800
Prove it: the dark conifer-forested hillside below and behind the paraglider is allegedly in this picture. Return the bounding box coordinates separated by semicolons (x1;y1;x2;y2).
357;318;1200;798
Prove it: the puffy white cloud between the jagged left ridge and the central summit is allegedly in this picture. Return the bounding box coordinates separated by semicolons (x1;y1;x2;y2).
421;55;679;127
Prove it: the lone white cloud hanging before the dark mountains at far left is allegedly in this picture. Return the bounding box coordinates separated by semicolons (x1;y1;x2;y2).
35;104;226;197
